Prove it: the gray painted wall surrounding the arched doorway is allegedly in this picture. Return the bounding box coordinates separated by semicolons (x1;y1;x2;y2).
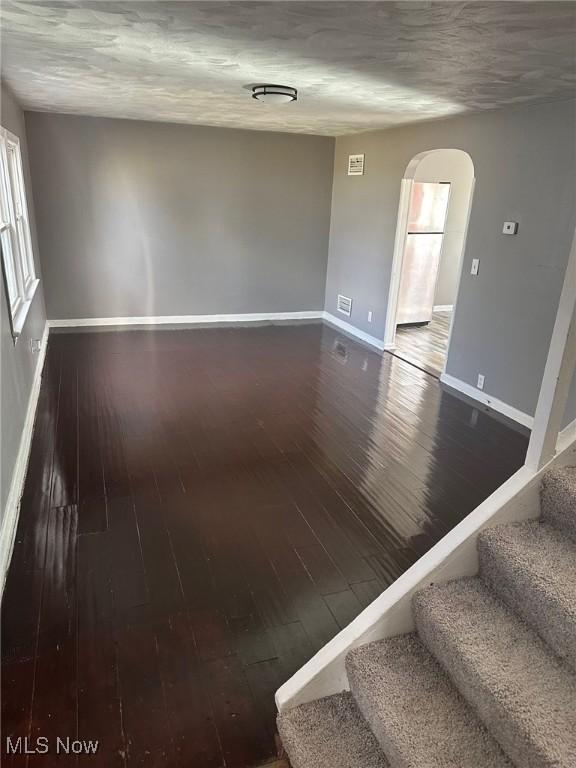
325;101;576;424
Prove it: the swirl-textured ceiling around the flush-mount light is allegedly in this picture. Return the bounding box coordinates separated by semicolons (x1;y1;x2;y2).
0;0;576;135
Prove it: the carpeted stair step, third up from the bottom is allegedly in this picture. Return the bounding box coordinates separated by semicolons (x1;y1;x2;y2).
413;578;576;768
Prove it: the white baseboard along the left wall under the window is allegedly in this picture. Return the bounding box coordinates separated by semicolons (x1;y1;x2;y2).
0;322;49;599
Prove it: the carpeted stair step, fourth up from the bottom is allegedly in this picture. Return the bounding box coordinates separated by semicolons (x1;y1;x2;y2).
478;521;576;671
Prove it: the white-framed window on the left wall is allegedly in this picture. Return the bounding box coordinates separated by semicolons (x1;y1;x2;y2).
0;127;40;337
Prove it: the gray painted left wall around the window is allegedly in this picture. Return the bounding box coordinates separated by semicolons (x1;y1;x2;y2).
0;83;46;525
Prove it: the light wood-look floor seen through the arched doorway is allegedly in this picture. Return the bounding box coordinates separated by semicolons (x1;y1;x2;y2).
394;312;452;378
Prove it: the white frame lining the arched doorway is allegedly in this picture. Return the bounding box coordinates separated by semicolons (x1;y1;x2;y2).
384;149;476;380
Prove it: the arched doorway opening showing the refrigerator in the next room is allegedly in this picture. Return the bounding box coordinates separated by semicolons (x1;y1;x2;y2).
384;149;474;377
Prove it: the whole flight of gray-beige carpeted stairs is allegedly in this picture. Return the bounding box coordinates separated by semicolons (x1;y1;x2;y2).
278;468;576;768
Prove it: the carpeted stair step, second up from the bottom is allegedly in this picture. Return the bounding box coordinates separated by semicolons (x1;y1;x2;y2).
346;634;511;768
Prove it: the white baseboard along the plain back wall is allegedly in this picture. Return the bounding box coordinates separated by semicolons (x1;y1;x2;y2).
48;309;324;328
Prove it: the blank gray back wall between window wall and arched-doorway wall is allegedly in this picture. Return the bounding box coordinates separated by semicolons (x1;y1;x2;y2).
26;113;334;319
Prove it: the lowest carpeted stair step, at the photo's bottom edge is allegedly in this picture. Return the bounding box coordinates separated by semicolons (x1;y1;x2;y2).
278;693;389;768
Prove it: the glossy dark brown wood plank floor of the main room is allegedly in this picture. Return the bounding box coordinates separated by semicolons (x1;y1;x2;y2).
2;325;527;768
